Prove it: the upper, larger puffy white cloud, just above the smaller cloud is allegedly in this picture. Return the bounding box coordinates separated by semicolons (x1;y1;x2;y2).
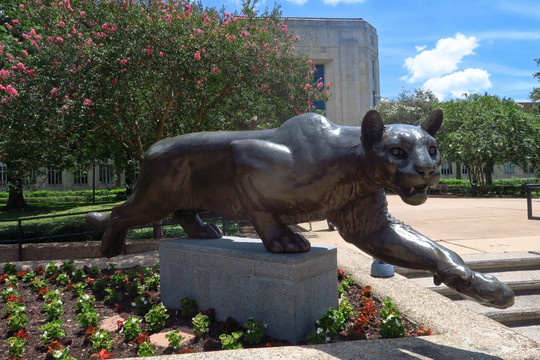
402;33;478;83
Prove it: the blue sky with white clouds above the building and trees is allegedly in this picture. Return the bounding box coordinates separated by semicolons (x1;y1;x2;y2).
203;0;540;101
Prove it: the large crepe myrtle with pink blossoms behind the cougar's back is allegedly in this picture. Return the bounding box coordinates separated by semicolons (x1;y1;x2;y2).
4;0;328;161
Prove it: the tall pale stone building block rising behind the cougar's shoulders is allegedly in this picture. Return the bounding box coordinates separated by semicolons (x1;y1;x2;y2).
286;18;380;126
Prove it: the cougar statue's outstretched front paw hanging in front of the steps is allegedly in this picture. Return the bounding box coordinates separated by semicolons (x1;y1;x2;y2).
448;271;514;309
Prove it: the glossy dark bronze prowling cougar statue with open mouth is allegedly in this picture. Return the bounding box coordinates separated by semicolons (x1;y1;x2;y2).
87;110;514;308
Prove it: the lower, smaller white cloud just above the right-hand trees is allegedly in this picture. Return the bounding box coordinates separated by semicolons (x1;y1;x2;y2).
423;68;491;100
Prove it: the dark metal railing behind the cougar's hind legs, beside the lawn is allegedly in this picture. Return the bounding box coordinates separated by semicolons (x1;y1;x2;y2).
0;209;228;261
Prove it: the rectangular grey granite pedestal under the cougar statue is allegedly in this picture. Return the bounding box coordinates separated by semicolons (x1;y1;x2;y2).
159;237;338;344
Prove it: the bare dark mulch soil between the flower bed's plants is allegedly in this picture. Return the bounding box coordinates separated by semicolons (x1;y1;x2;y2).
0;262;430;360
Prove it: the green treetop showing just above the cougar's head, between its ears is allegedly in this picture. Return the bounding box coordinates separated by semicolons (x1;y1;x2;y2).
375;89;439;125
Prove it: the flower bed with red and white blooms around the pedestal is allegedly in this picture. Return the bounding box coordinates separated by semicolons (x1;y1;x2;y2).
0;261;431;359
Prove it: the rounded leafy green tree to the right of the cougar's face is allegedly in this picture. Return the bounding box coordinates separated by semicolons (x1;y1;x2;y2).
437;94;540;192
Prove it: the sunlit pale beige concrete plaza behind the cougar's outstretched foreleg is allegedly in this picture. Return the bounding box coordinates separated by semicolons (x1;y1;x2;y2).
301;195;540;255
